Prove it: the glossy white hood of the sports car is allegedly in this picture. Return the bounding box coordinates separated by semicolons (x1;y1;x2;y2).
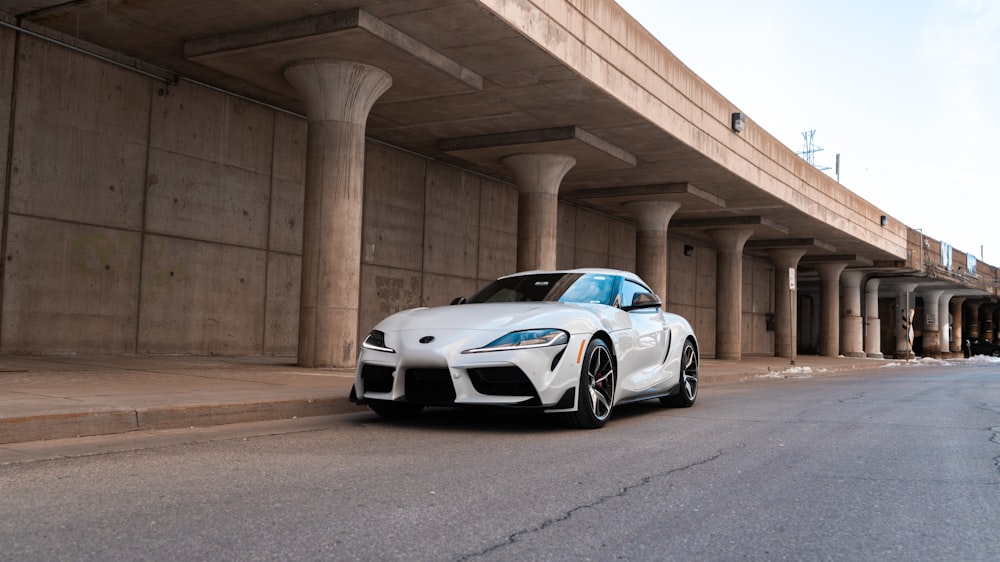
375;302;625;334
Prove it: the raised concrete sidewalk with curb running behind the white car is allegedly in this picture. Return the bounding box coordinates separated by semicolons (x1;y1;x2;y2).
0;355;892;444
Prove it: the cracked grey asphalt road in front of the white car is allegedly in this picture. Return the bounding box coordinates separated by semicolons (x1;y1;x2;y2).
0;365;1000;561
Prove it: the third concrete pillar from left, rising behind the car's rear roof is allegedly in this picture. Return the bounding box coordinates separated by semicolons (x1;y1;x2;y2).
623;201;681;304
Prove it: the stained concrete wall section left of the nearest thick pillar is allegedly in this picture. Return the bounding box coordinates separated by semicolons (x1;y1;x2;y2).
0;36;294;354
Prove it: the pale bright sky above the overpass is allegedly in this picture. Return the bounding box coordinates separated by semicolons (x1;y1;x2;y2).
618;0;1000;265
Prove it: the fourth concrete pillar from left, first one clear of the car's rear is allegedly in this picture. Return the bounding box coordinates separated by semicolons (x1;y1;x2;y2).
706;229;753;359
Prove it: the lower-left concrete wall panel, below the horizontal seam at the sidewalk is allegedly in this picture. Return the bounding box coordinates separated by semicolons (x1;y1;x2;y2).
2;215;141;353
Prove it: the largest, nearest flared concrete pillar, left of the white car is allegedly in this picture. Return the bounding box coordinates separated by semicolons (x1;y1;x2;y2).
285;60;392;367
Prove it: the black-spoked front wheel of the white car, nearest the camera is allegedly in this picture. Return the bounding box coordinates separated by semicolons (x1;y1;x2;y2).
564;338;618;429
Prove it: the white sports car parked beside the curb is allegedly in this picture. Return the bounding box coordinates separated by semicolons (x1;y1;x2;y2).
351;269;699;428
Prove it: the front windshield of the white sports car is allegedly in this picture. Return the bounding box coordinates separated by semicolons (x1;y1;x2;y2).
468;273;615;305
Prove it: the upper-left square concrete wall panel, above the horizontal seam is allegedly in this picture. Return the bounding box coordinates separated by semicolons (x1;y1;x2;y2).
10;37;152;230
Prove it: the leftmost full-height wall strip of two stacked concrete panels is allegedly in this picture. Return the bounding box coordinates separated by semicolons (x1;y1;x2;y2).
0;32;152;353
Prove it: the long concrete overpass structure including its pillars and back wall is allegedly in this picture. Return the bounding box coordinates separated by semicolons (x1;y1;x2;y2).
0;0;996;366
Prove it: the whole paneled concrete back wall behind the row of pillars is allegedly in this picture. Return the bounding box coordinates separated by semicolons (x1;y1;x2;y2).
0;30;773;357
